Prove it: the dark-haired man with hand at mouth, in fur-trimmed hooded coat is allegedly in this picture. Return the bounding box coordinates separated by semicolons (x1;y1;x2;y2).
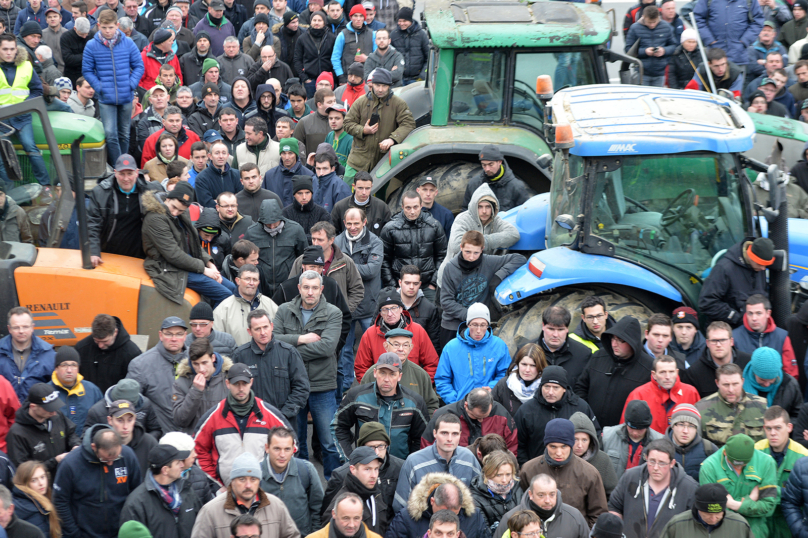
172;338;233;433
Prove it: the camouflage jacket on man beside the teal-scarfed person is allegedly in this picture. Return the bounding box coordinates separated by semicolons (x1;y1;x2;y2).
696;392;768;446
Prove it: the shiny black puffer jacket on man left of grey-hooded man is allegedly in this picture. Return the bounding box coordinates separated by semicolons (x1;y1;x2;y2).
381;211;447;287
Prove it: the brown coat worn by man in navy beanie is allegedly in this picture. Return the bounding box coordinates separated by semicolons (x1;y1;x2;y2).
519;452;608;526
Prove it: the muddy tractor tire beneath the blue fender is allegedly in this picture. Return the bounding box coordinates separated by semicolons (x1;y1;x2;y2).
495;288;661;356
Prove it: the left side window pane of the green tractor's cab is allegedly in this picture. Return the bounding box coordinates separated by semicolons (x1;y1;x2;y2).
451;51;507;122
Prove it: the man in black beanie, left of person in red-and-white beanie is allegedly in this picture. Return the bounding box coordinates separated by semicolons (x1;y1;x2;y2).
603;400;665;478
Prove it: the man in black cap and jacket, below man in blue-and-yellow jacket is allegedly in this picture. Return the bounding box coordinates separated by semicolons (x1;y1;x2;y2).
6;383;80;476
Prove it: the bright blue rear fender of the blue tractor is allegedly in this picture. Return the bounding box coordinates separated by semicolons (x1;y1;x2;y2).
496;247;682;305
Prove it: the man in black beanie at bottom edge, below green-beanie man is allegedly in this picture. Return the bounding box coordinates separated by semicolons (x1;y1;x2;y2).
660;484;757;538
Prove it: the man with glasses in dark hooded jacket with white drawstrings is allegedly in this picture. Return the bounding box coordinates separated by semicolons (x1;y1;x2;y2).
609;439;699;538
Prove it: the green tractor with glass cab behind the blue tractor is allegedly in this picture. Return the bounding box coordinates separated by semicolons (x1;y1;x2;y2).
371;0;642;213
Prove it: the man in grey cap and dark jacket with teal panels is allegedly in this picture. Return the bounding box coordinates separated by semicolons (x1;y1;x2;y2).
331;352;431;462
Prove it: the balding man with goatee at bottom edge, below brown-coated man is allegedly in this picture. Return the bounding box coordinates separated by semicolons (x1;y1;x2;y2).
497;474;588;538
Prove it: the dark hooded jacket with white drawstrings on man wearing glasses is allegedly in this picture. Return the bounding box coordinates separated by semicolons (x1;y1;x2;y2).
609;463;699;538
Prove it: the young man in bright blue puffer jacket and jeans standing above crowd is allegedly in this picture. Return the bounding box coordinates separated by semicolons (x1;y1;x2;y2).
82;9;144;166
